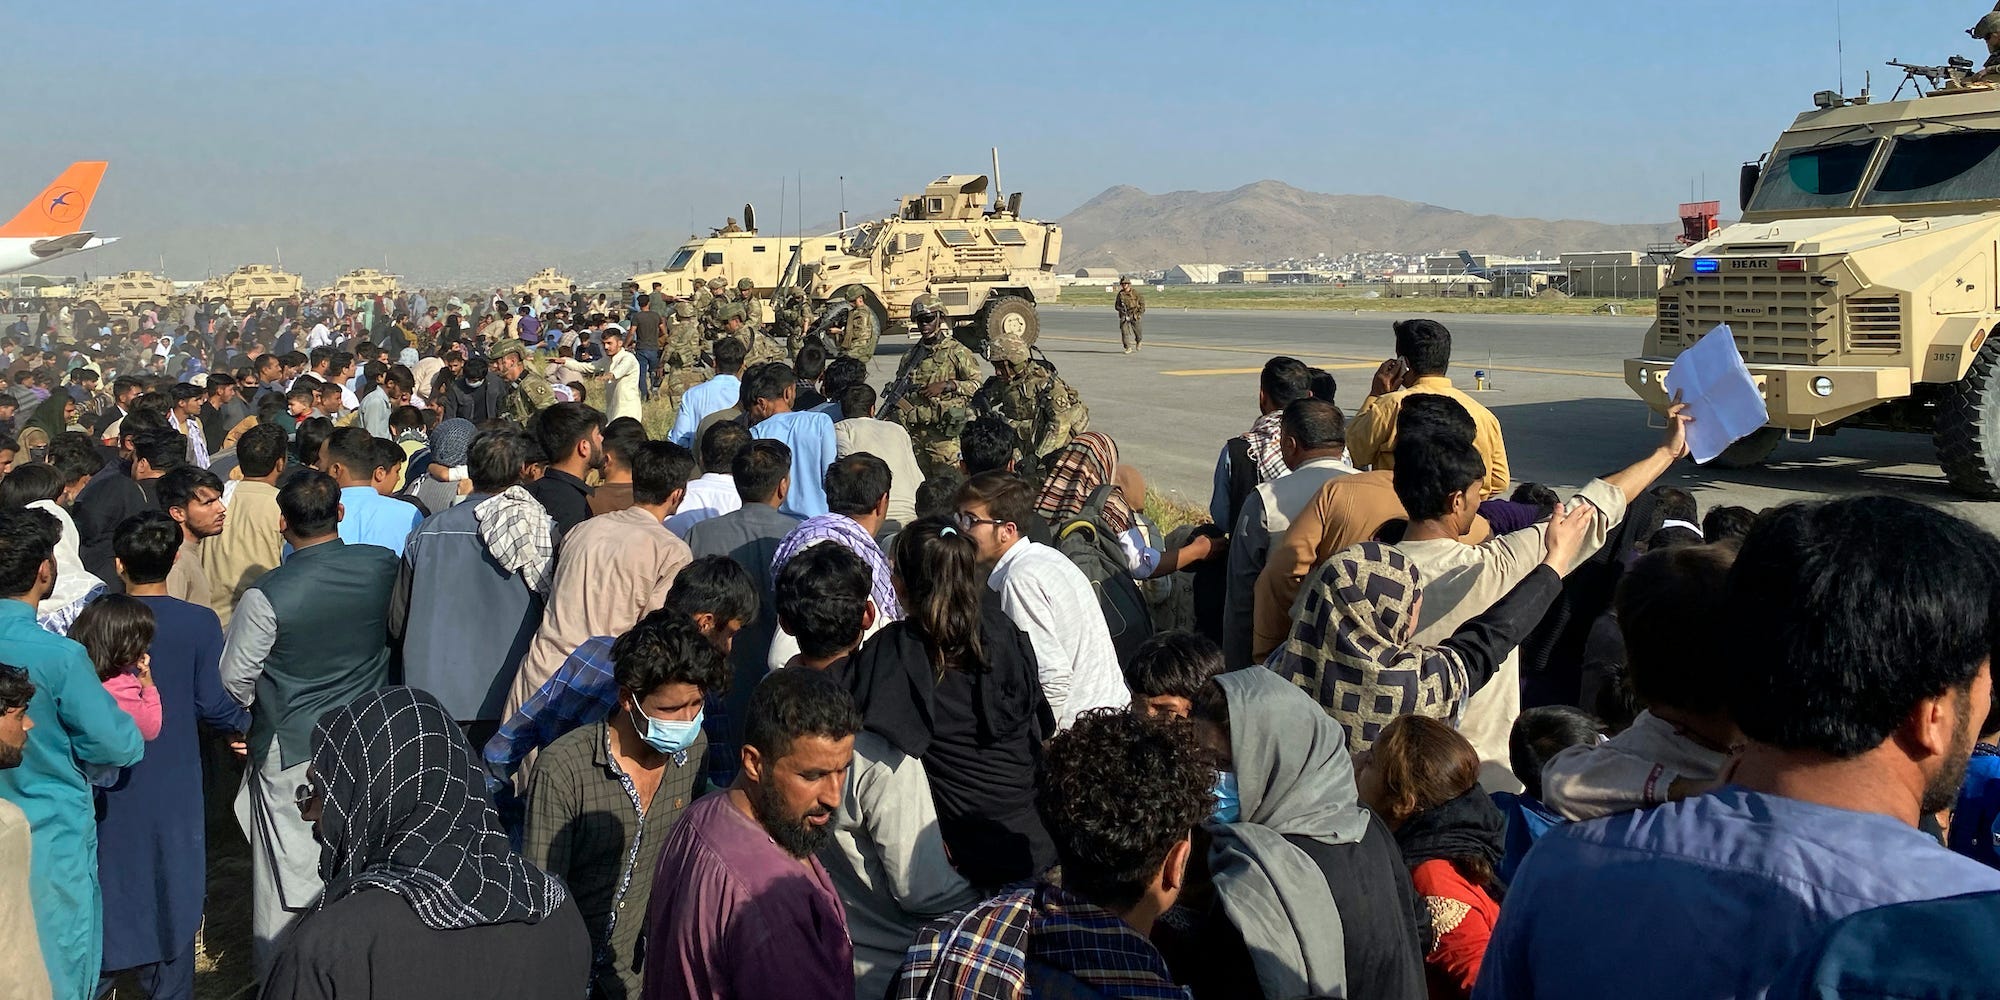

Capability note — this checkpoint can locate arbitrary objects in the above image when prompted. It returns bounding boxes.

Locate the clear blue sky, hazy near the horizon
[11,0,1984,274]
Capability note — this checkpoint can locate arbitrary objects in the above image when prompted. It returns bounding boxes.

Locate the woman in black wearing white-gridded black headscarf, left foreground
[262,688,590,1000]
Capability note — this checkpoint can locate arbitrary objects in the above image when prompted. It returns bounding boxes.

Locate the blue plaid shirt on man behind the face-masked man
[484,636,738,792]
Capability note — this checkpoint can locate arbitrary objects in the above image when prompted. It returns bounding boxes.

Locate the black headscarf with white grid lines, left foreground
[312,688,568,930]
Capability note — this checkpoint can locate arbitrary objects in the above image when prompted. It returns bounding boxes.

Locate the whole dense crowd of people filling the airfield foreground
[0,286,2000,1000]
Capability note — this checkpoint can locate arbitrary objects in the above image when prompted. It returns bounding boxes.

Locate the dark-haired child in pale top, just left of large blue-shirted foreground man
[1542,546,1740,820]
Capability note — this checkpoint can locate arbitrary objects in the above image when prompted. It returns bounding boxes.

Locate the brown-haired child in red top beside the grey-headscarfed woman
[1356,716,1506,998]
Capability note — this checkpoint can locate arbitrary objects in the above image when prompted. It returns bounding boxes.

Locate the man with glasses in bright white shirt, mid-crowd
[956,472,1132,730]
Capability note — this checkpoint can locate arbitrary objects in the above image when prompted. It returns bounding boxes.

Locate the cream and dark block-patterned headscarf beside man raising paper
[1270,542,1472,752]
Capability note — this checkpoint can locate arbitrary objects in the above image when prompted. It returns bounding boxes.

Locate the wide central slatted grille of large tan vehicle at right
[1678,274,1838,364]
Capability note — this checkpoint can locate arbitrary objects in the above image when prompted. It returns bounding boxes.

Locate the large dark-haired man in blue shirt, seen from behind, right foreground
[1480,496,2000,998]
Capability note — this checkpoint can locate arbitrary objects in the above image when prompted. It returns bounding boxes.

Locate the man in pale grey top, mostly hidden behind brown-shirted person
[1222,398,1354,670]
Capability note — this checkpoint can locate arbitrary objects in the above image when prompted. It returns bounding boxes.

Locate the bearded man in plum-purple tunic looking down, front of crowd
[642,666,862,1000]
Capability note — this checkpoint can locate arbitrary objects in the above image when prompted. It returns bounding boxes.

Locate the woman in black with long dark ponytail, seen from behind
[846,518,1056,890]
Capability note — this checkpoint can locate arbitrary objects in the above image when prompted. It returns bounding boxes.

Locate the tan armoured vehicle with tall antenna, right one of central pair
[784,174,1062,350]
